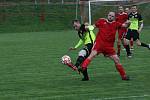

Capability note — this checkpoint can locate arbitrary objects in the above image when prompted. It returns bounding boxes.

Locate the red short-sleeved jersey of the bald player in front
[95,18,122,47]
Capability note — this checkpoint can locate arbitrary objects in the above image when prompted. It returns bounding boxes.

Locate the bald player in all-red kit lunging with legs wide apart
[82,12,129,80]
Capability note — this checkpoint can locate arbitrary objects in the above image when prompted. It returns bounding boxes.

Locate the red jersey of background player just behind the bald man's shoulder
[116,12,128,24]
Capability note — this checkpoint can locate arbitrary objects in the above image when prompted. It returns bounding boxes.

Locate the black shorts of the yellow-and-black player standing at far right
[126,29,139,41]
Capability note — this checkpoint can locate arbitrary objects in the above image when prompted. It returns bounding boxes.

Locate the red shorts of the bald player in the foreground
[92,41,116,56]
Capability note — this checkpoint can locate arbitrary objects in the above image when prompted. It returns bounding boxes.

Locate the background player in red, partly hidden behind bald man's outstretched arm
[116,6,128,56]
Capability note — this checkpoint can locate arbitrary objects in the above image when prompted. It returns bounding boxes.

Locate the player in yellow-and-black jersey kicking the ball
[67,20,95,81]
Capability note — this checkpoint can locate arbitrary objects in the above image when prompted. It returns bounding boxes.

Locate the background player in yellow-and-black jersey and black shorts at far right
[126,5,150,57]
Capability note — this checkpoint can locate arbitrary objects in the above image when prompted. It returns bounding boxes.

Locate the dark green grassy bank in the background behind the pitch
[0,0,150,33]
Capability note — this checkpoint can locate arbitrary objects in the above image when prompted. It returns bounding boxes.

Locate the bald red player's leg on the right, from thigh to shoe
[109,54,129,80]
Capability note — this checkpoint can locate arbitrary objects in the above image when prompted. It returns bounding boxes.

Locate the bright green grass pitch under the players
[0,29,150,100]
